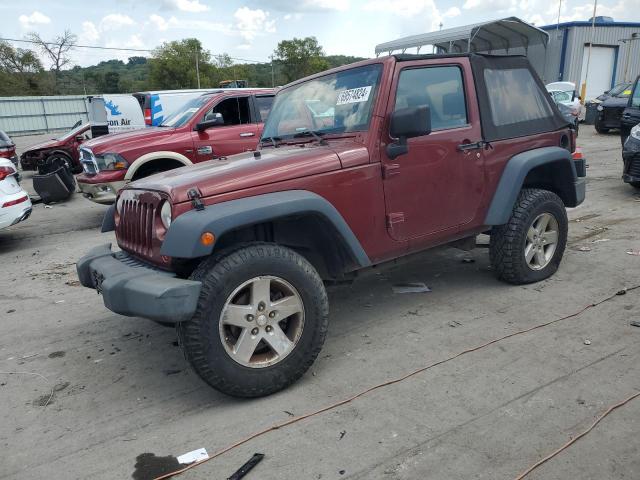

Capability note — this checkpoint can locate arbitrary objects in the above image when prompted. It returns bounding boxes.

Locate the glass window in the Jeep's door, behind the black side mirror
[395,67,468,130]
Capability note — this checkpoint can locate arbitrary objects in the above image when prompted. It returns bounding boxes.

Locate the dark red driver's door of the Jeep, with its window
[382,58,484,243]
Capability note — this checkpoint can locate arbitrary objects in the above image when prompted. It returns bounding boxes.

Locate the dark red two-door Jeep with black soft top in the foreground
[77,54,585,397]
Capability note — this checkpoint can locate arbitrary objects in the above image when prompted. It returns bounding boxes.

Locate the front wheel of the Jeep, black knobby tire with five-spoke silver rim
[177,243,329,397]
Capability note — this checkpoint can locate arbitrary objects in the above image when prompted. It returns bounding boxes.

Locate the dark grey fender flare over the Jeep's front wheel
[160,190,371,267]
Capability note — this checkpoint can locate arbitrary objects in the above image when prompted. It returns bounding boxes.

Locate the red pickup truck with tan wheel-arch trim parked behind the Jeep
[77,89,275,204]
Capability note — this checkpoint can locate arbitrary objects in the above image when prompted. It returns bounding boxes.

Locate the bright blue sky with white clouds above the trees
[0,0,640,65]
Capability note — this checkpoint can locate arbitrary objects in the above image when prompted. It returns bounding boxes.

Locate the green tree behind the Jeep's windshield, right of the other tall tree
[273,37,329,82]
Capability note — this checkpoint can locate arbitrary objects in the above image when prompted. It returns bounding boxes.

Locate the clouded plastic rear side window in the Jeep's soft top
[484,68,553,126]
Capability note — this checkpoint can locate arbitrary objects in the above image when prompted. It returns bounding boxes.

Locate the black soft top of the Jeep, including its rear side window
[394,53,568,142]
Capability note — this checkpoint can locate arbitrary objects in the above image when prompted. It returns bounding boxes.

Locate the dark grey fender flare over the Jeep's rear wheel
[484,147,584,225]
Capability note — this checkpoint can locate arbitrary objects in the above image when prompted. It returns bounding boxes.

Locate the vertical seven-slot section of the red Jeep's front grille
[116,198,158,257]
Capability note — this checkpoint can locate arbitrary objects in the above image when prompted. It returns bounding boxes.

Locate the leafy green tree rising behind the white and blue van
[149,38,211,89]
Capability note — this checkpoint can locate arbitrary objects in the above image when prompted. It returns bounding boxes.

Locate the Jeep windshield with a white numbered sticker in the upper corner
[262,64,382,140]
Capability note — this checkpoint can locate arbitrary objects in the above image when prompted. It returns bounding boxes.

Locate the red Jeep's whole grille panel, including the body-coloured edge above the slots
[116,189,163,260]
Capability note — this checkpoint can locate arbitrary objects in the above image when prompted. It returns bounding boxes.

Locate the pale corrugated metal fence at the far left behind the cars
[0,95,89,136]
